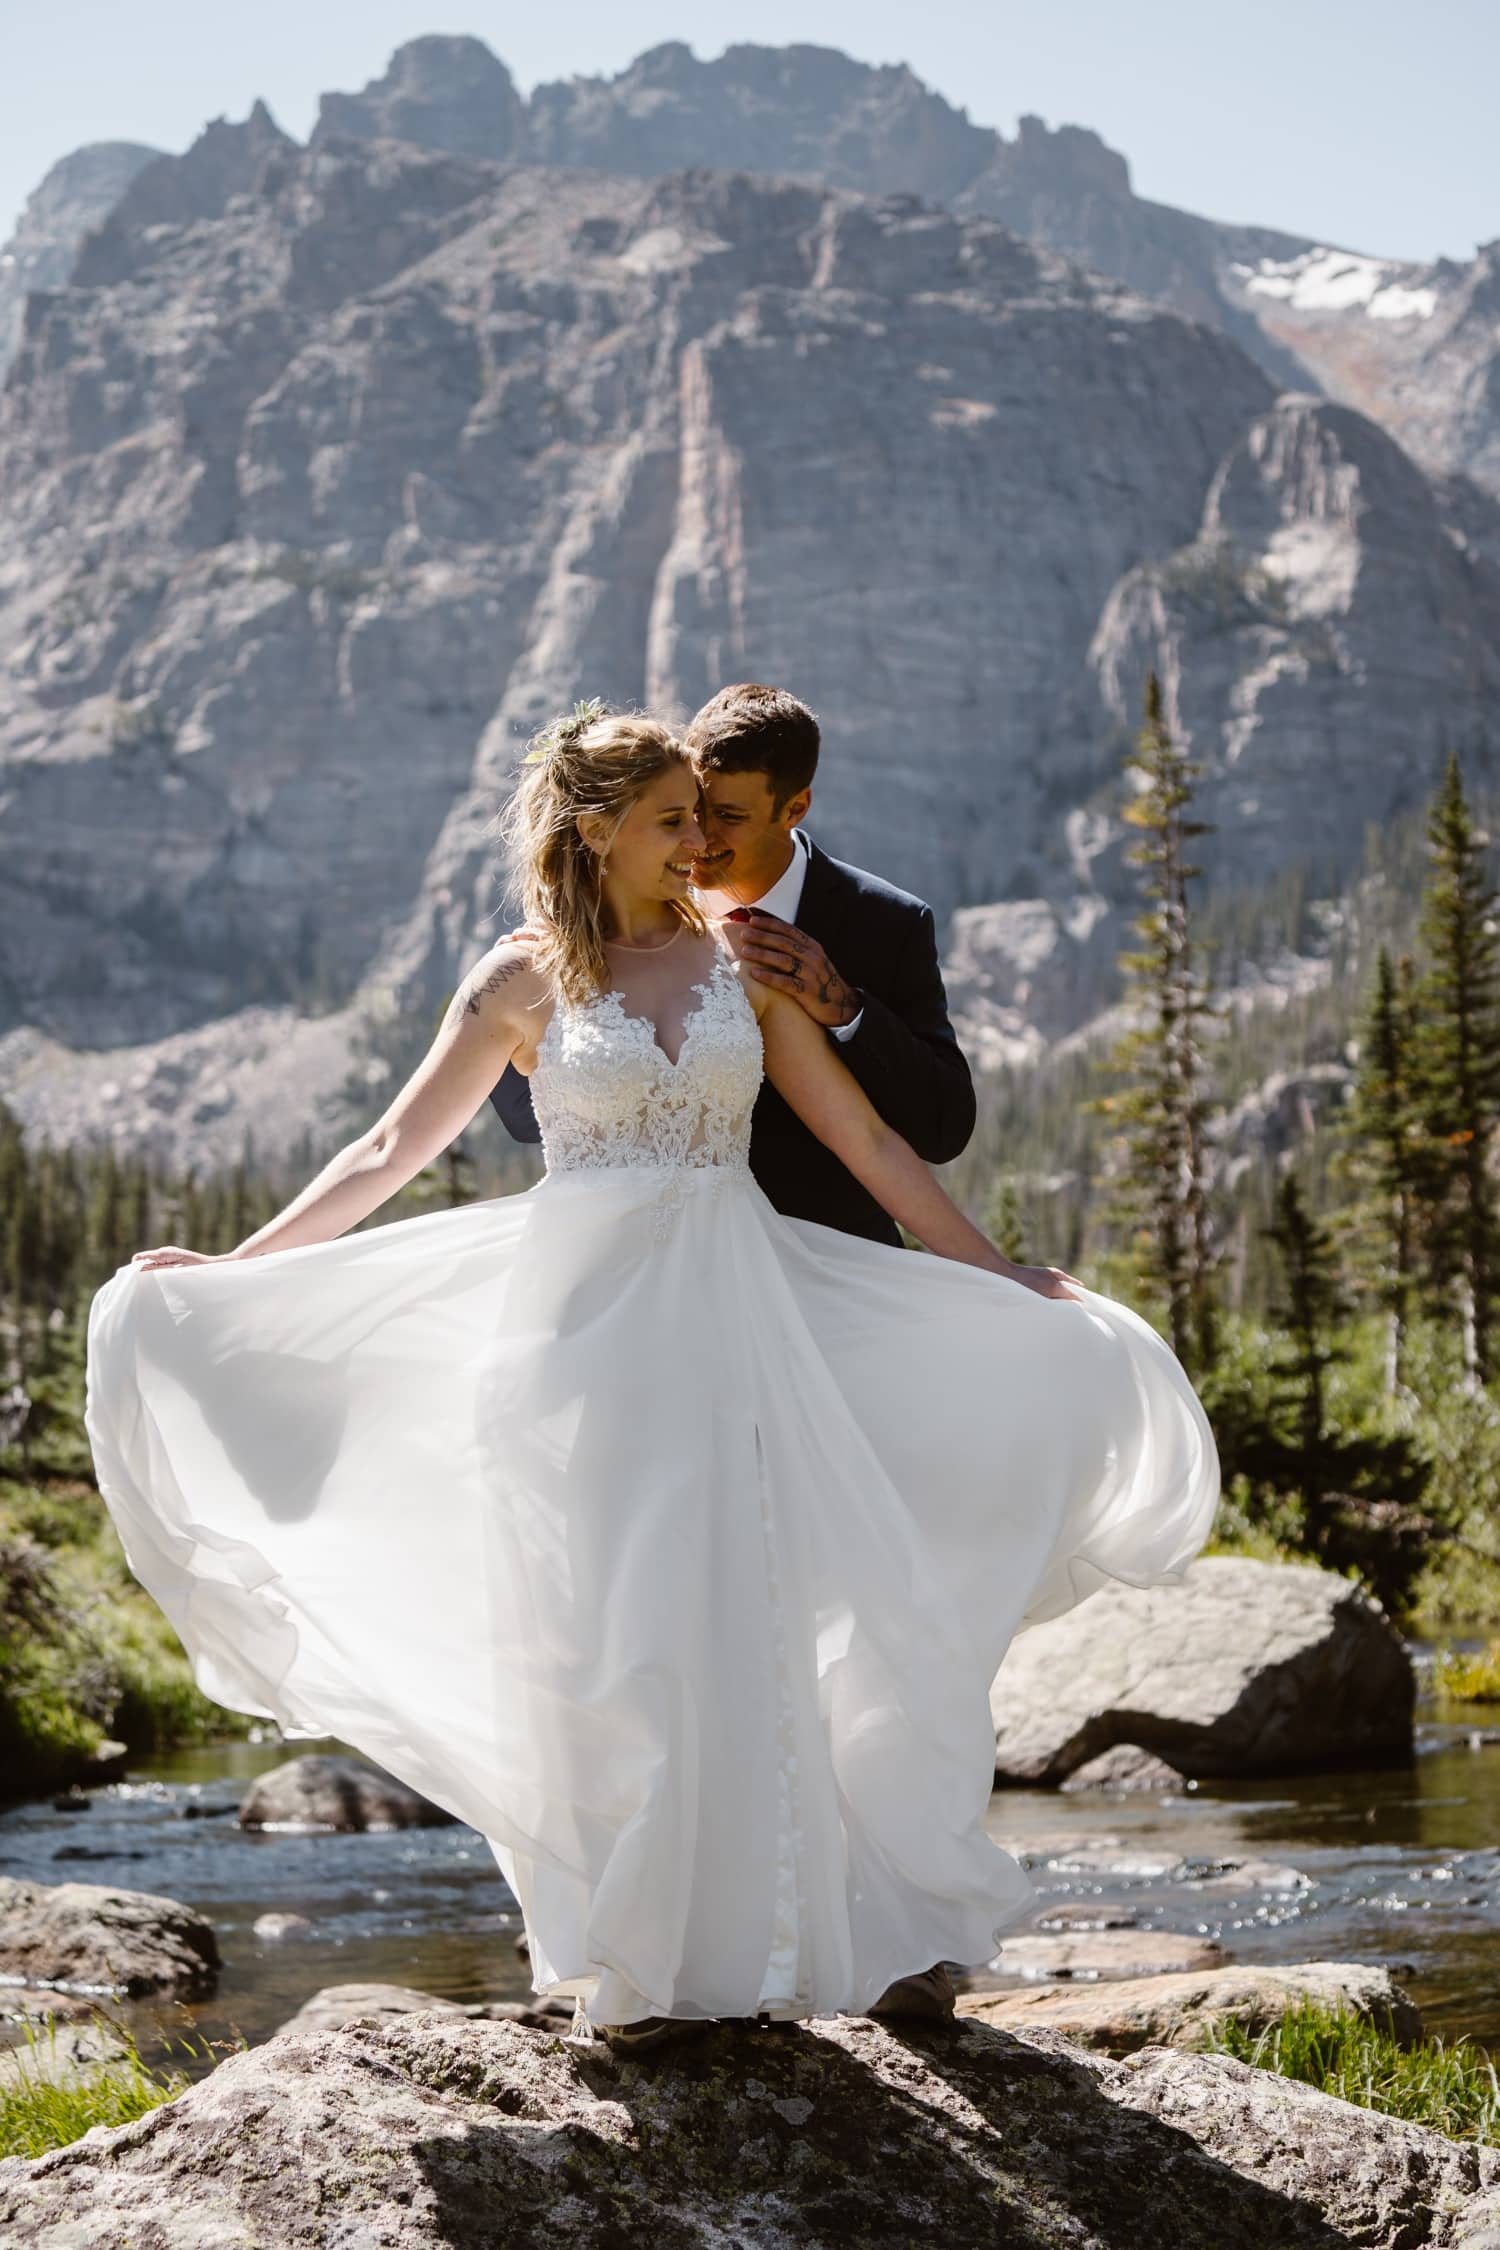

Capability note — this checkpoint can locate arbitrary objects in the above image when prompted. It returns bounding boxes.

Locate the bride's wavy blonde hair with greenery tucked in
[497,700,708,1001]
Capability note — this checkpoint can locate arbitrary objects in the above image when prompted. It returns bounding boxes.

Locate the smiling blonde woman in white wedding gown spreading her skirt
[85,718,1219,2043]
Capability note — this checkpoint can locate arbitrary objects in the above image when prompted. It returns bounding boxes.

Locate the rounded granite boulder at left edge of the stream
[0,1874,220,1998]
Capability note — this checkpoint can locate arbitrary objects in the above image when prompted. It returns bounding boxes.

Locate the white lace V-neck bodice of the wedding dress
[531,950,762,1215]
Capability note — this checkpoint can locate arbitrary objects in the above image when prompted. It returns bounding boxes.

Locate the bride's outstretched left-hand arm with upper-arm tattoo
[133,941,544,1267]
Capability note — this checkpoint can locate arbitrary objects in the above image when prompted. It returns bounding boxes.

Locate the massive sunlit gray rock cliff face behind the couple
[0,52,1500,1161]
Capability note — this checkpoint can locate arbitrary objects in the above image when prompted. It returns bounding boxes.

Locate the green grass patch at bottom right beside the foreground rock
[1205,2000,1500,2147]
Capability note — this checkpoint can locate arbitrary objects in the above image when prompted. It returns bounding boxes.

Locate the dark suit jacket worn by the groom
[490,844,974,1242]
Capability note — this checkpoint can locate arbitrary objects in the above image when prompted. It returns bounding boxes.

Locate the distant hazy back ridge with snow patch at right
[299,38,1500,491]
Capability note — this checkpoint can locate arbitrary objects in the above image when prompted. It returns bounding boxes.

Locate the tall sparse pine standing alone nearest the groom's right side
[1100,673,1214,1370]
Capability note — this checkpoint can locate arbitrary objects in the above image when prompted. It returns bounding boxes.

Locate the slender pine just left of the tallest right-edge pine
[1343,947,1426,1395]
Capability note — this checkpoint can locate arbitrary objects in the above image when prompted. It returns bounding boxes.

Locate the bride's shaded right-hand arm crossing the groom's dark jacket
[742,970,1073,1296]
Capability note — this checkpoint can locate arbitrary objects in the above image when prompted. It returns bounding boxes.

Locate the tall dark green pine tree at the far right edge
[1415,756,1500,1386]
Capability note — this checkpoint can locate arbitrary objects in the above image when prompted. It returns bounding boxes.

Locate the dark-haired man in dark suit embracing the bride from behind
[490,684,974,1242]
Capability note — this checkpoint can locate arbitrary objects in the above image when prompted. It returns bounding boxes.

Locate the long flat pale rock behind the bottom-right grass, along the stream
[958,1962,1421,2054]
